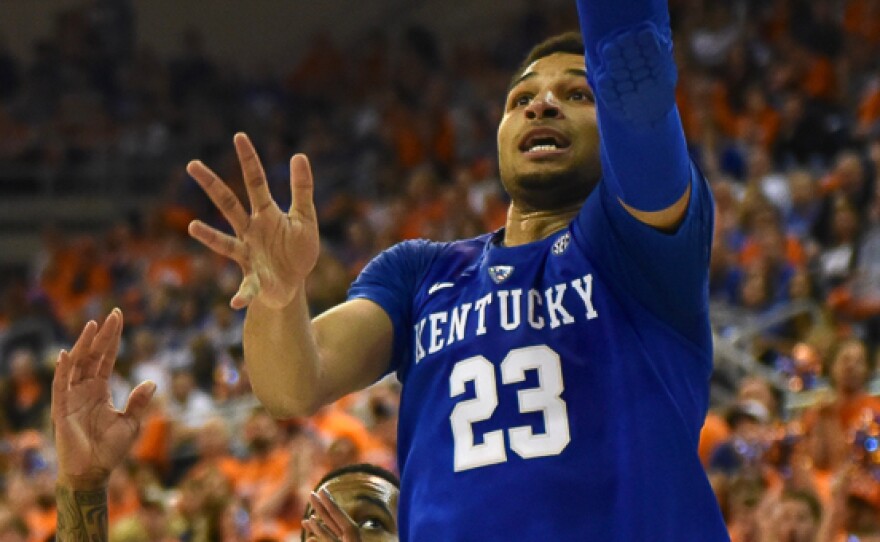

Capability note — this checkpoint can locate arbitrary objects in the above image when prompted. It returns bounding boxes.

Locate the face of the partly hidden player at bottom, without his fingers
[319,472,400,542]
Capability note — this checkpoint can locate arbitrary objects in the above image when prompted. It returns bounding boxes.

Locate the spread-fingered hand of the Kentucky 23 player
[187,134,319,309]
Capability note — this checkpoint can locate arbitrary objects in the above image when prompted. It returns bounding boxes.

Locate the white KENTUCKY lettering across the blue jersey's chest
[415,274,599,363]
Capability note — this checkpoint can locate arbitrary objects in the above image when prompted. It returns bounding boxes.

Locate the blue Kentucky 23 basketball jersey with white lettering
[350,164,728,542]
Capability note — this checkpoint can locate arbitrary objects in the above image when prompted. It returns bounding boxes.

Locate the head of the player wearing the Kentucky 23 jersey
[498,32,601,215]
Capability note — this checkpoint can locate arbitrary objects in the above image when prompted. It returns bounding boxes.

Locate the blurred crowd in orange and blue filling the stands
[0,0,880,542]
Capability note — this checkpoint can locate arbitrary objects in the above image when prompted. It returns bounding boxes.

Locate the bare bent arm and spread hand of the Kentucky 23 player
[187,134,393,418]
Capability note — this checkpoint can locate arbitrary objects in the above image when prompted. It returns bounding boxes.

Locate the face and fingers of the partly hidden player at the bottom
[302,472,400,542]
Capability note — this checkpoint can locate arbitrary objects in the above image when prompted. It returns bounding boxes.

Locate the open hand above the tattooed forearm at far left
[52,309,156,488]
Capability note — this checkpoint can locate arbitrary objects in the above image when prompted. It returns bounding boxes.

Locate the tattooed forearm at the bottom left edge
[55,484,108,542]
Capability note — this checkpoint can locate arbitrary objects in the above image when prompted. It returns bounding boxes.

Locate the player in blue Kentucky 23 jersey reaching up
[188,0,728,542]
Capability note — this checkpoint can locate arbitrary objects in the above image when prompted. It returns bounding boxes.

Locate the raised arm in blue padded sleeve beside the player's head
[577,0,691,229]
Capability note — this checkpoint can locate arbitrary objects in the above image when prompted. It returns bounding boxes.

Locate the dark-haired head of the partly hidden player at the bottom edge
[300,463,400,542]
